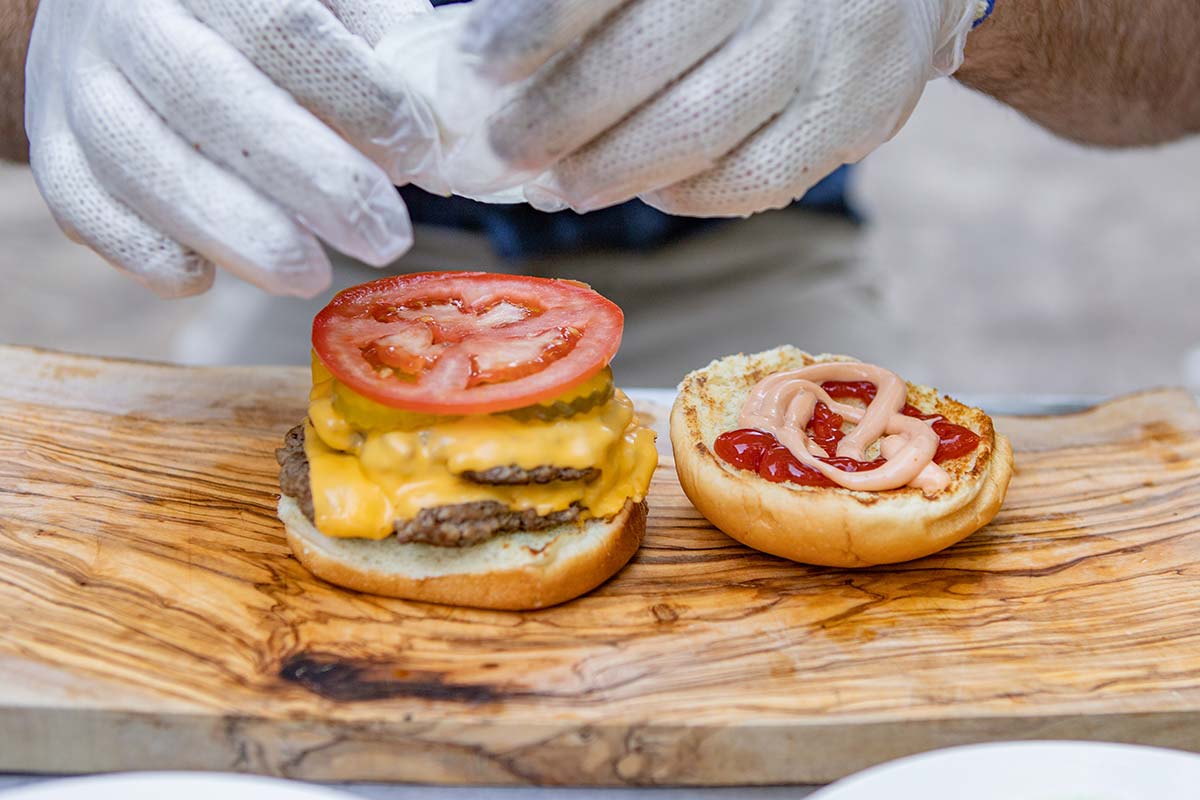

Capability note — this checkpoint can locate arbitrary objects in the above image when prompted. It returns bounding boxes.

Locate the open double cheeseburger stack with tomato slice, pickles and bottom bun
[276,272,658,609]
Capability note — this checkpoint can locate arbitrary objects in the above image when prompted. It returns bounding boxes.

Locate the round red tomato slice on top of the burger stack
[312,272,624,414]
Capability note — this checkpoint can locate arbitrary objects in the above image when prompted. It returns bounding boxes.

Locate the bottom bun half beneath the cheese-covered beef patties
[278,495,646,609]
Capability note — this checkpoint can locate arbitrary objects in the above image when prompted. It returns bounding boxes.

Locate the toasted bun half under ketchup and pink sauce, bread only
[671,347,1013,567]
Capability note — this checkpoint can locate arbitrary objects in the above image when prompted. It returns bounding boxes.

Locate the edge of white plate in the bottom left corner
[0,772,353,800]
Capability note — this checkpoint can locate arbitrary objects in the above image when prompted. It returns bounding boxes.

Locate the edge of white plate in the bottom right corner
[809,741,1200,800]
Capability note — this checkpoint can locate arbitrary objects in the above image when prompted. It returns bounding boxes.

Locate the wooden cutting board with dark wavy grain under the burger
[0,348,1200,784]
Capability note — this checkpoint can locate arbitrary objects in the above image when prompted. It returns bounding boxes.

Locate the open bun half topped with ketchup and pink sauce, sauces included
[671,347,1013,567]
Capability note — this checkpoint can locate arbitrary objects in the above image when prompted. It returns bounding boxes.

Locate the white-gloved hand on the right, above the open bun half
[460,0,979,216]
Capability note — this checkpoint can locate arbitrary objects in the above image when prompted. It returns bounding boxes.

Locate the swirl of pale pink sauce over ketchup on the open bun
[738,361,950,495]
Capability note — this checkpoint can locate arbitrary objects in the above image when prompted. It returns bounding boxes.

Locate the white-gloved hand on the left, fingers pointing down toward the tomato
[25,0,437,296]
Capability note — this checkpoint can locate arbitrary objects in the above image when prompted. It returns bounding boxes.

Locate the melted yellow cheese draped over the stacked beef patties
[305,359,658,539]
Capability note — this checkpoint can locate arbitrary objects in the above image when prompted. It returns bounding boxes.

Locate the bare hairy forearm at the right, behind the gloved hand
[956,0,1200,146]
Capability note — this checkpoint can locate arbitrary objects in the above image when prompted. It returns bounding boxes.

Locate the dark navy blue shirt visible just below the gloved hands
[400,0,858,260]
